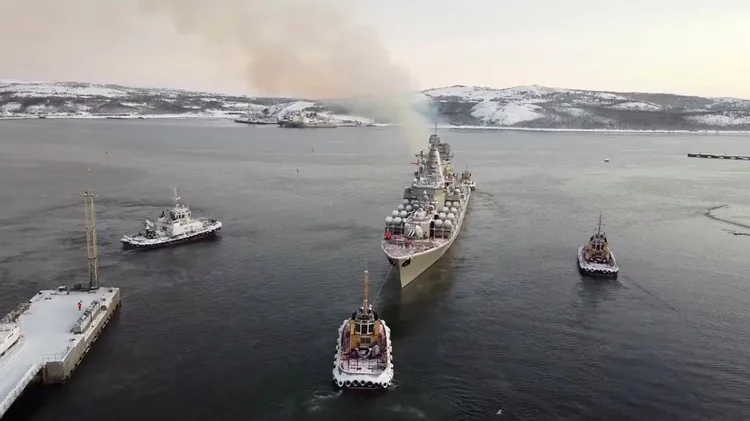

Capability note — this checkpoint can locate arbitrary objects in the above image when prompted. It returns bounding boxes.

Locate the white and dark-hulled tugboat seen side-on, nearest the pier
[120,189,222,249]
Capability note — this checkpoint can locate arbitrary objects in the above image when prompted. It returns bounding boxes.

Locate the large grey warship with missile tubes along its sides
[381,132,472,288]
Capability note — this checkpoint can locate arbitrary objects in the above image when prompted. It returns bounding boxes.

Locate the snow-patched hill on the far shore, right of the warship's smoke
[422,86,750,130]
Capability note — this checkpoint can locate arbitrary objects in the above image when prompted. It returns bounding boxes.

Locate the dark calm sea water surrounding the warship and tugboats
[0,120,750,421]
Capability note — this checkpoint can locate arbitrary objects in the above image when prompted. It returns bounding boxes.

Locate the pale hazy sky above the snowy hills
[0,0,750,98]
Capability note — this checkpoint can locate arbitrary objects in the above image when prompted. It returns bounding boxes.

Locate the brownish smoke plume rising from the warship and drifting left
[0,0,427,149]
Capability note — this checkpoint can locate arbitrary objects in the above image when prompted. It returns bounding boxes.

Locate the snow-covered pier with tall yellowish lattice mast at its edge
[0,191,120,418]
